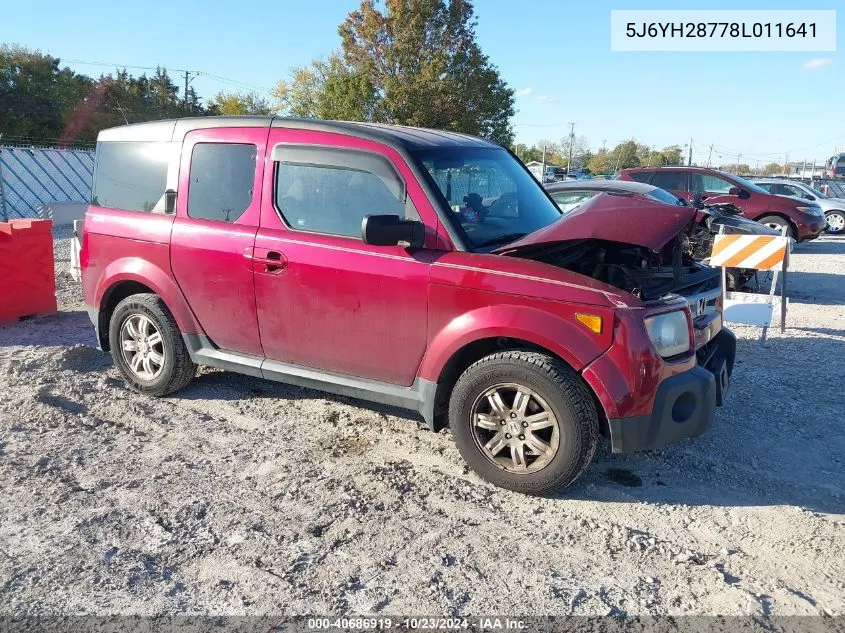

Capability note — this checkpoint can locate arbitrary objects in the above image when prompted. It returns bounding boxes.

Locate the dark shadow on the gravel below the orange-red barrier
[0,310,97,347]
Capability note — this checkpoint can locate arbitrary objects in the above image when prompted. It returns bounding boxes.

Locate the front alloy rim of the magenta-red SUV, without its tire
[471,383,560,474]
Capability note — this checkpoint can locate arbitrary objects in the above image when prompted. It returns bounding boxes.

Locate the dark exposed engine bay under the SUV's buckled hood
[510,233,720,301]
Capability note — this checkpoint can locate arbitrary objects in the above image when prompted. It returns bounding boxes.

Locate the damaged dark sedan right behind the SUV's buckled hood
[546,180,780,290]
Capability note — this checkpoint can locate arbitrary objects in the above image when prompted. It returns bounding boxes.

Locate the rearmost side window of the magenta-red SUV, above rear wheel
[91,142,172,213]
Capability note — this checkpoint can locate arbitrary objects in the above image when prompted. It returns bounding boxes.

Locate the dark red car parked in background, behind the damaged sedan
[619,167,827,242]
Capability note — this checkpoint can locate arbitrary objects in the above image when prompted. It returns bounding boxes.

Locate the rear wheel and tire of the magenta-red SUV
[109,293,197,396]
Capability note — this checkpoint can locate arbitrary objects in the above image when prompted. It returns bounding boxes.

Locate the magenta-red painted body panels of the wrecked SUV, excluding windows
[83,117,728,440]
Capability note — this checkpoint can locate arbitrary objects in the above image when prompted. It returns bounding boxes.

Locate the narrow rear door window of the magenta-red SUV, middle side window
[188,143,258,222]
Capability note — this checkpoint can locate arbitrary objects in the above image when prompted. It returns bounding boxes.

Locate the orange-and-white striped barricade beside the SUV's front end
[710,227,792,344]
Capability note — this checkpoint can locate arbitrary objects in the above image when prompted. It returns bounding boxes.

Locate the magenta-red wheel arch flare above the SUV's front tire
[418,305,613,382]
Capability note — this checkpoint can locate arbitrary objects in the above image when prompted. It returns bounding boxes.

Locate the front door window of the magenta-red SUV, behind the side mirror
[273,145,406,239]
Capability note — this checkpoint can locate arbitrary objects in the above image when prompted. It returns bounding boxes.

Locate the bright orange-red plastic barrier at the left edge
[0,220,56,323]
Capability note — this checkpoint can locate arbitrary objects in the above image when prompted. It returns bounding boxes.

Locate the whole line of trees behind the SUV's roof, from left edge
[0,0,515,145]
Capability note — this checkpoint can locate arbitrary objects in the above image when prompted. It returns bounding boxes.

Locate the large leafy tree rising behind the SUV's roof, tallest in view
[276,0,514,145]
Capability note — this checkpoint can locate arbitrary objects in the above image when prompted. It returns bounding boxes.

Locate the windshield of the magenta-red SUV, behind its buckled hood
[415,148,561,250]
